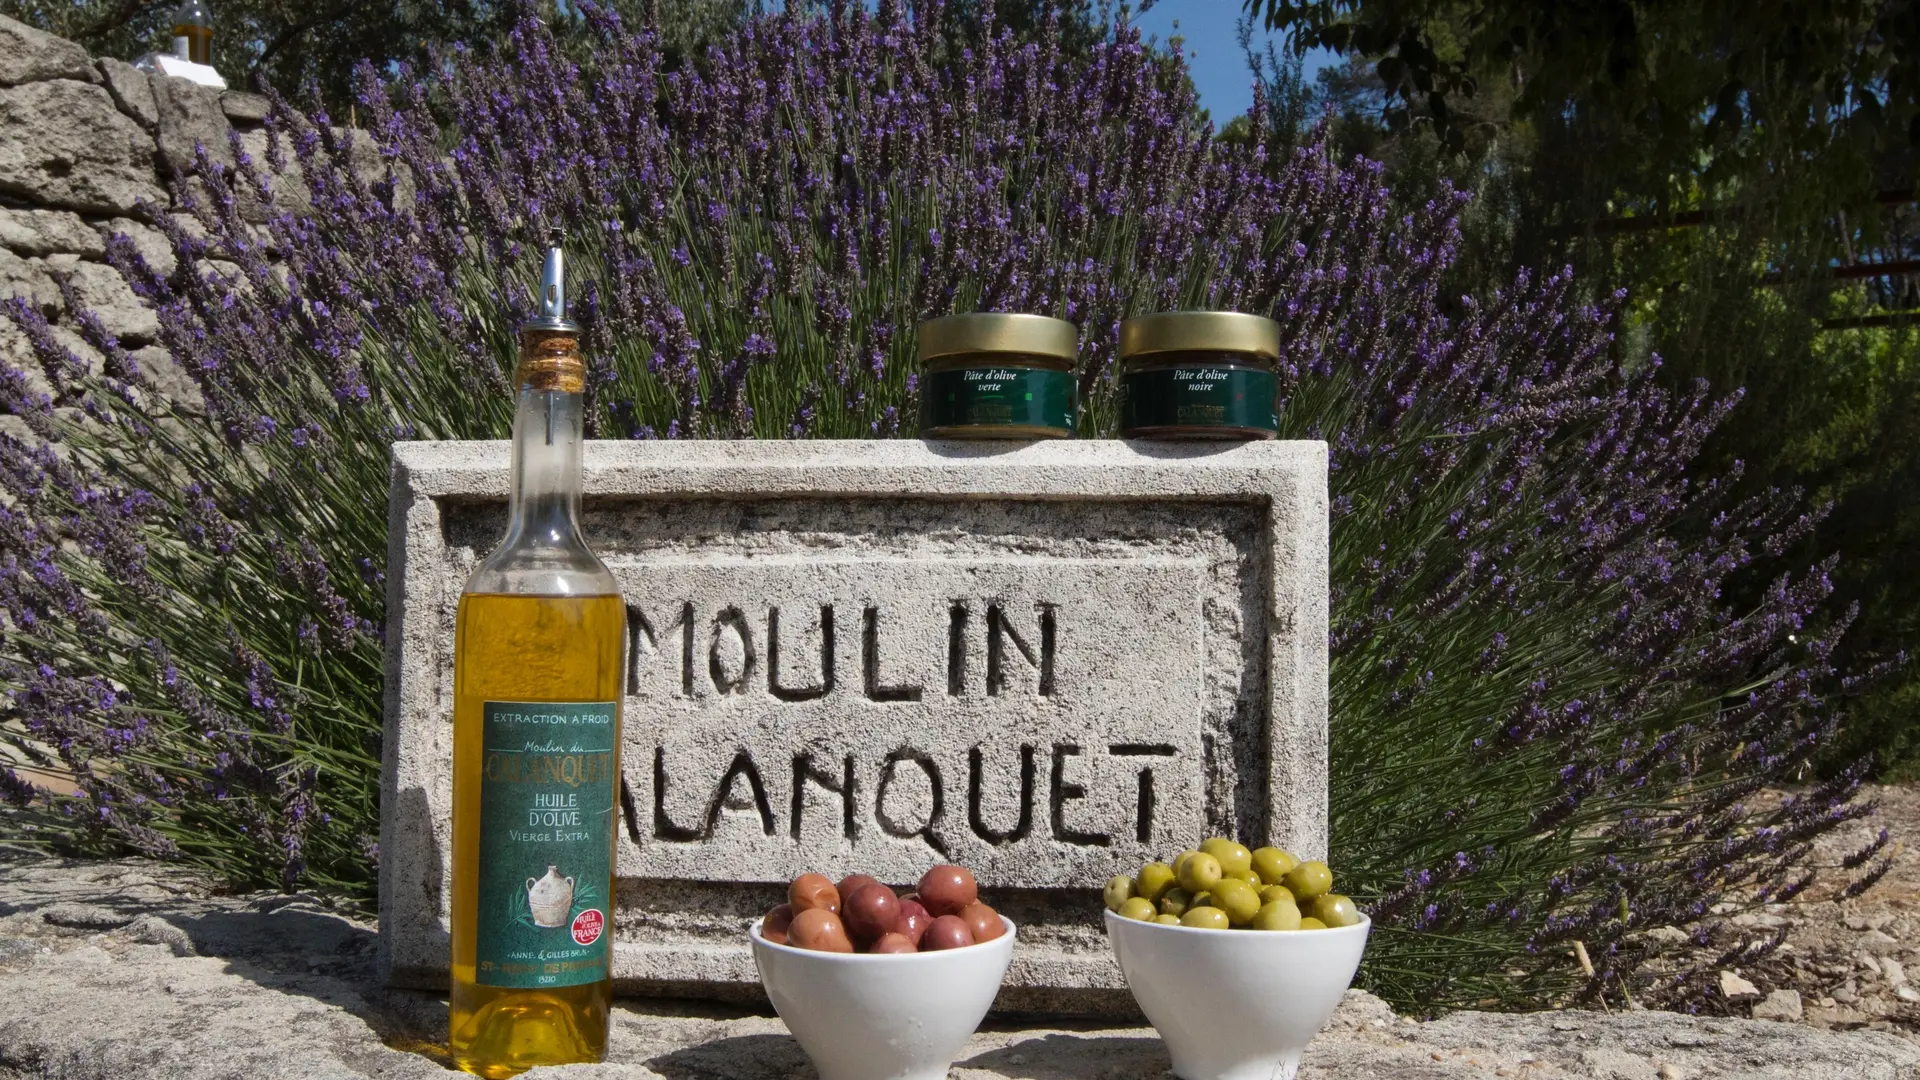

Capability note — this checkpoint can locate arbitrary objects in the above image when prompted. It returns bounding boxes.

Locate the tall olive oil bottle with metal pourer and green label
[447,238,626,1076]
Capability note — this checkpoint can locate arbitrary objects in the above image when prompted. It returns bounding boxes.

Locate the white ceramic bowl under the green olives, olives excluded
[1106,911,1373,1080]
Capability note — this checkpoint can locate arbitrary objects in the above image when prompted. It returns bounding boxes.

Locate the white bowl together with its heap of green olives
[1104,838,1373,1080]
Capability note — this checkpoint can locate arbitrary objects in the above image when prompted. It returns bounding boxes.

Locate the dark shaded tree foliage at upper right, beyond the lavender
[1248,0,1920,763]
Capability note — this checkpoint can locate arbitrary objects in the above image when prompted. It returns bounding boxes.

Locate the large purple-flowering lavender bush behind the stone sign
[0,4,1884,1007]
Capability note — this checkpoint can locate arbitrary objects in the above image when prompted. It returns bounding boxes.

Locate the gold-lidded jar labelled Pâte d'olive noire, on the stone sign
[1119,311,1281,438]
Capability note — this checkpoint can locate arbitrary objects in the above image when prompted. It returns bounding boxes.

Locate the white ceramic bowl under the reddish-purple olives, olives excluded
[749,915,1014,1080]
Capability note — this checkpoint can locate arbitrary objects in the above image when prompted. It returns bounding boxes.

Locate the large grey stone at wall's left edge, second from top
[0,79,165,213]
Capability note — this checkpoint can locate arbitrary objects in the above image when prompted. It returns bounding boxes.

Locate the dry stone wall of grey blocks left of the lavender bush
[0,15,288,424]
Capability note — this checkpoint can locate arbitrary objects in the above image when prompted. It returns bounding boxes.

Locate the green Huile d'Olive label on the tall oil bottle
[474,701,618,988]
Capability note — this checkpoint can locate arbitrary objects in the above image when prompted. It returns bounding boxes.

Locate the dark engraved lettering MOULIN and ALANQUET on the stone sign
[626,601,1179,855]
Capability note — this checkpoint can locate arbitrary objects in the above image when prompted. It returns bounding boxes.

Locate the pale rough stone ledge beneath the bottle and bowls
[0,853,1920,1080]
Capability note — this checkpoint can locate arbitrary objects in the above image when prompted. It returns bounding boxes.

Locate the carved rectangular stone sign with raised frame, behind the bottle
[380,440,1327,1011]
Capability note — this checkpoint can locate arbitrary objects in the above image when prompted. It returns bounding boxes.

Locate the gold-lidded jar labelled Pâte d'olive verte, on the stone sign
[920,313,1079,438]
